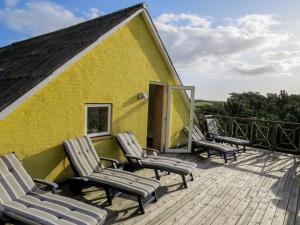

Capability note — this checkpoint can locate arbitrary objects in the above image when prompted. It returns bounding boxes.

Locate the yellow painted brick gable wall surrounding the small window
[0,16,190,180]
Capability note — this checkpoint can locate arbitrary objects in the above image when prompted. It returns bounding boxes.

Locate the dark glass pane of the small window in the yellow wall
[87,107,109,134]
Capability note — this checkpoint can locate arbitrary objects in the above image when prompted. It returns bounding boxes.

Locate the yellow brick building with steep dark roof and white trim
[0,4,193,180]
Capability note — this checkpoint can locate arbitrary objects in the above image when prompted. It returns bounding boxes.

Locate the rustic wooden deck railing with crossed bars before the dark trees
[199,116,300,154]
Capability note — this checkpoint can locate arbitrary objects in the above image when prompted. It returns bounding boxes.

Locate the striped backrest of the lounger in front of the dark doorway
[116,132,144,158]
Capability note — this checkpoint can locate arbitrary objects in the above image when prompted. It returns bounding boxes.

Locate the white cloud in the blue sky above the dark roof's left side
[0,0,102,35]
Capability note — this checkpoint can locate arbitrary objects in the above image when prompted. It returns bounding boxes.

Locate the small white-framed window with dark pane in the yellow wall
[86,104,111,137]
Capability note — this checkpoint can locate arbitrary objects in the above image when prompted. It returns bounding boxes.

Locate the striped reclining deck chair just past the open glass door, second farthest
[183,125,238,163]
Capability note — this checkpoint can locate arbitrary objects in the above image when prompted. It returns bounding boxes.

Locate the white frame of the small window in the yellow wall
[84,103,112,137]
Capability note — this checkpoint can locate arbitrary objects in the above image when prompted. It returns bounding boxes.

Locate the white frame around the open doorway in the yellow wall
[148,81,168,152]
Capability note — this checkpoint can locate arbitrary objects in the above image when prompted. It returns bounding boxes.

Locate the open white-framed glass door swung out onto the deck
[165,85,195,153]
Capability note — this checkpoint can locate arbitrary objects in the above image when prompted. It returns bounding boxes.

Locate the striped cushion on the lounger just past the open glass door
[184,125,236,152]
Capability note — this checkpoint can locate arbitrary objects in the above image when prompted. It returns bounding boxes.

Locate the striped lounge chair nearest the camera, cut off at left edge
[0,153,107,225]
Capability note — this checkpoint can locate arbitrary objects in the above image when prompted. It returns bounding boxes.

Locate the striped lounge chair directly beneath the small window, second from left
[64,136,160,214]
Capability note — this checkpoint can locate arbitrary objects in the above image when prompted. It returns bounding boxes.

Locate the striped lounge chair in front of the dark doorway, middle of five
[116,132,197,188]
